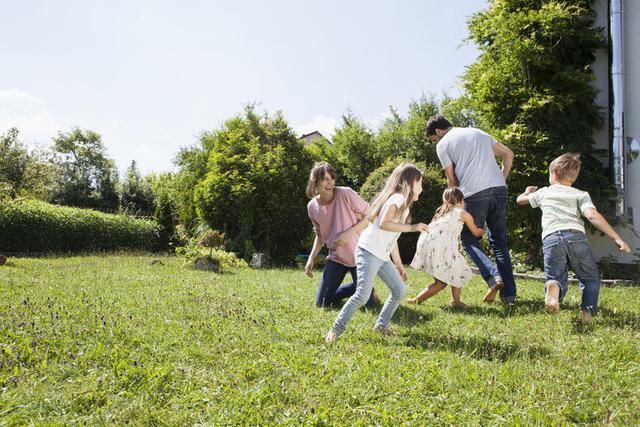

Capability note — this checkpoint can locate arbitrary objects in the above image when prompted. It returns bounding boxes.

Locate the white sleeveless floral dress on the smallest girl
[411,208,473,288]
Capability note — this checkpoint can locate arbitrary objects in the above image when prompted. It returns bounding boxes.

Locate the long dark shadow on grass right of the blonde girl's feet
[406,333,551,362]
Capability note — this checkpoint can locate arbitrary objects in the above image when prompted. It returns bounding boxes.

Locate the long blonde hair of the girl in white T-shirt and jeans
[369,162,422,222]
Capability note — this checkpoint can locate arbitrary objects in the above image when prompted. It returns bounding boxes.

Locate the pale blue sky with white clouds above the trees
[0,0,488,174]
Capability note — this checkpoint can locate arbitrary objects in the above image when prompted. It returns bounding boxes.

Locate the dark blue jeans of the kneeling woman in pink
[316,260,375,307]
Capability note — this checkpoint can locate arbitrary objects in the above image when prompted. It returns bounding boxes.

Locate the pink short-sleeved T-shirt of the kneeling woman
[307,187,369,267]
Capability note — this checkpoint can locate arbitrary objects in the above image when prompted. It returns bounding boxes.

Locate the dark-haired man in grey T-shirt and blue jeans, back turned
[426,114,516,304]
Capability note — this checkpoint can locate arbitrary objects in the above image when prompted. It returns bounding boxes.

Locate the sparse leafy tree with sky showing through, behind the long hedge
[53,128,118,209]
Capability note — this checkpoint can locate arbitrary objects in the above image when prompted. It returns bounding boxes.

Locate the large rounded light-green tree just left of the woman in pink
[194,106,312,264]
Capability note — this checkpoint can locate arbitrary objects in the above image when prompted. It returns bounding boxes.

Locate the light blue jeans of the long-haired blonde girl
[331,248,407,335]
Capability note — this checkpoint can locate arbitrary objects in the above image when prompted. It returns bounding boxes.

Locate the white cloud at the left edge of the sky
[0,88,60,143]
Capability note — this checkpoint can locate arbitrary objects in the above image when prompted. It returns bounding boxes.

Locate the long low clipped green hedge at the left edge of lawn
[0,200,163,252]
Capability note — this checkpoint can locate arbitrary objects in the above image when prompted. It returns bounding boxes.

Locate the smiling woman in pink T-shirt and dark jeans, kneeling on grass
[304,162,376,307]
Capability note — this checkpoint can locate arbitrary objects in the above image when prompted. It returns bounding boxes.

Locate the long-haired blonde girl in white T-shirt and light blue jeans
[325,163,427,343]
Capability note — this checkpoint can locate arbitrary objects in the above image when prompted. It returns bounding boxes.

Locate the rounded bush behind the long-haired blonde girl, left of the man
[360,159,447,263]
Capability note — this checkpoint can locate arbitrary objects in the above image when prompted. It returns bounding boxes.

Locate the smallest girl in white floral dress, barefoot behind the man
[408,187,482,307]
